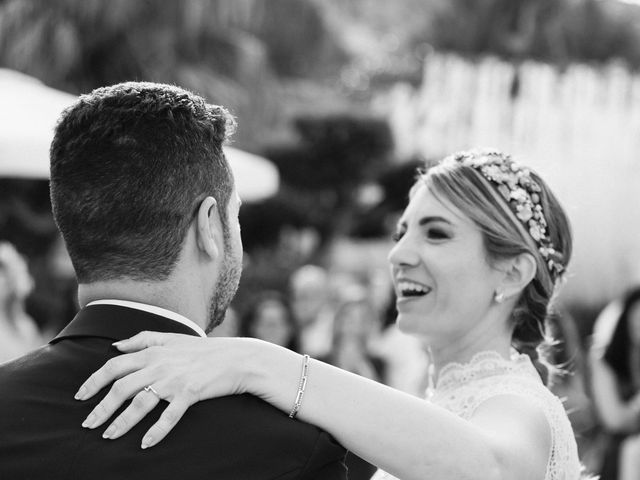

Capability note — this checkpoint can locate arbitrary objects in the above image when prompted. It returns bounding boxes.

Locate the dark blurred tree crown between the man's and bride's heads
[266,114,393,248]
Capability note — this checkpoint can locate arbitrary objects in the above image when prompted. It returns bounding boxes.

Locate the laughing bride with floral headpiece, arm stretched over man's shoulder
[76,151,581,480]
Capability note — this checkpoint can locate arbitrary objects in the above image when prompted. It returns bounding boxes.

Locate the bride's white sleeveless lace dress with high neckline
[372,352,581,480]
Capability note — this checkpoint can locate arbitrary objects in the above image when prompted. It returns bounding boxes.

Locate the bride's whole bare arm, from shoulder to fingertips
[77,333,550,480]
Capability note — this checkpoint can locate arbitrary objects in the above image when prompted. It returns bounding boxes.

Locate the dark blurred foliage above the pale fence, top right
[424,0,640,67]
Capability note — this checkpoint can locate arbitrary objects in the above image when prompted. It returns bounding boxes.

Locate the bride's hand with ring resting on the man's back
[75,332,256,448]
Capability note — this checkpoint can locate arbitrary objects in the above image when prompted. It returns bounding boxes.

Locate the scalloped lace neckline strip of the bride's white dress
[427,350,539,397]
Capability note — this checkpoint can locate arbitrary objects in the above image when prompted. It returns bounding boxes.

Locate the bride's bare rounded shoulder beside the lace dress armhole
[470,394,552,479]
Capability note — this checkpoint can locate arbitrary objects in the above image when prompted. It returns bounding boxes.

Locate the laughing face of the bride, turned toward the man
[389,185,508,344]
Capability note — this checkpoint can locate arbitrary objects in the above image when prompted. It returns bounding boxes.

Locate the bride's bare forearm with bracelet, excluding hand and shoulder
[247,347,499,480]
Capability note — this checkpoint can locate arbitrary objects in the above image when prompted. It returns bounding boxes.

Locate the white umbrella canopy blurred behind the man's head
[0,69,279,201]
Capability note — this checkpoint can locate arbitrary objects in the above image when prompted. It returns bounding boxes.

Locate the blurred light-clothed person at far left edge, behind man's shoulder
[0,242,43,363]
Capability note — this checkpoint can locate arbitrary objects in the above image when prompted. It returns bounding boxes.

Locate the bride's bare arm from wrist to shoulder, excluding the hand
[252,348,550,480]
